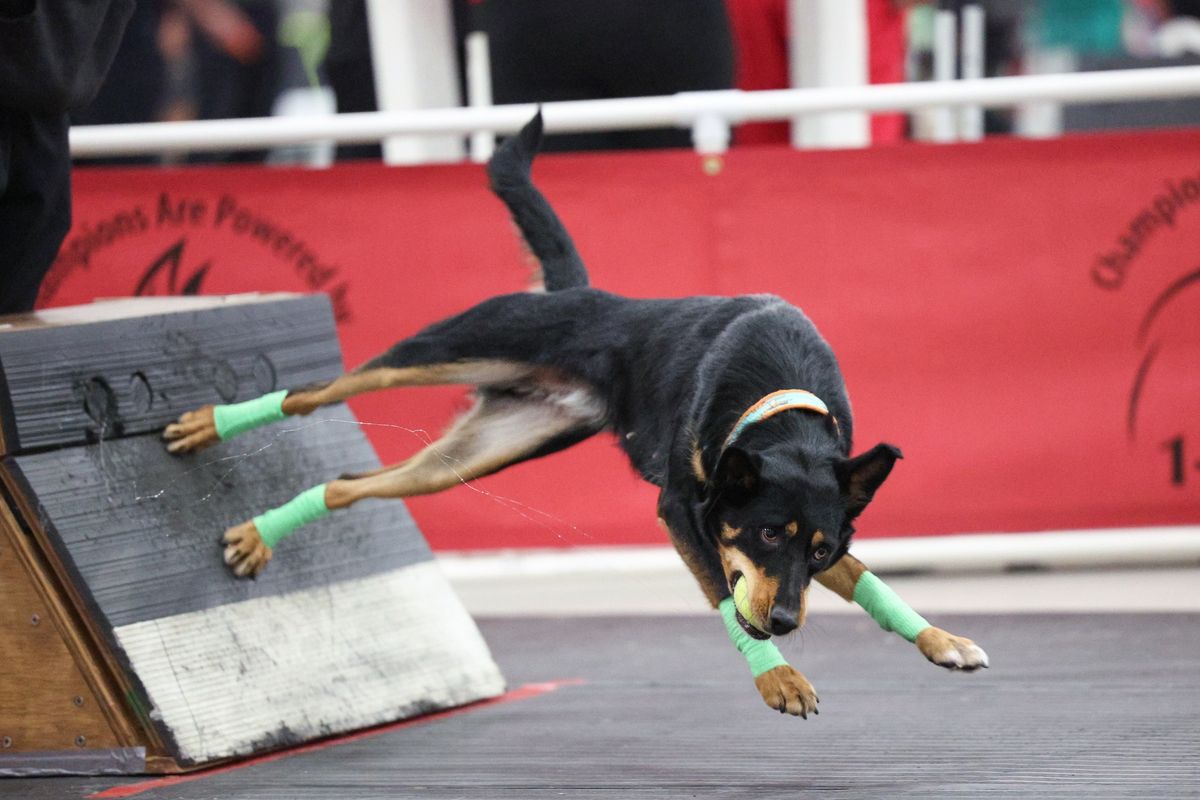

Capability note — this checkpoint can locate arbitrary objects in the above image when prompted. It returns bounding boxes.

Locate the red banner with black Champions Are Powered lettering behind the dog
[42,132,1200,548]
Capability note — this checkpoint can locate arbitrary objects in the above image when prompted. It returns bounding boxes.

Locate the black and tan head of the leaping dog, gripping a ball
[704,440,901,638]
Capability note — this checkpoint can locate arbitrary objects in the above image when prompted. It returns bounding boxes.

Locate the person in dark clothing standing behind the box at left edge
[0,0,133,314]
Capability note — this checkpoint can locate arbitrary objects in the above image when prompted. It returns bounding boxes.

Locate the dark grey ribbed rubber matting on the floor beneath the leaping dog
[0,618,1200,800]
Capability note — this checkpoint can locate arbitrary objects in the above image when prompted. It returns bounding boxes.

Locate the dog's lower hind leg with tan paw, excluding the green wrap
[224,395,602,577]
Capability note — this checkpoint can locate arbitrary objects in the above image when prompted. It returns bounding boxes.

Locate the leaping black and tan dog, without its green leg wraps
[164,115,986,715]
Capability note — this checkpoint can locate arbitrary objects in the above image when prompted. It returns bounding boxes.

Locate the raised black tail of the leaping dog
[487,108,588,291]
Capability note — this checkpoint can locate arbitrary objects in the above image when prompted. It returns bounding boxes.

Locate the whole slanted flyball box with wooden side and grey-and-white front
[0,295,504,775]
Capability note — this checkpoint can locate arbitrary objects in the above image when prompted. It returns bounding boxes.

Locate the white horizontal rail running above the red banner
[71,66,1200,156]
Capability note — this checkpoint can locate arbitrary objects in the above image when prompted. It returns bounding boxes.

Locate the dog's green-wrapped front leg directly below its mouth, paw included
[659,501,820,720]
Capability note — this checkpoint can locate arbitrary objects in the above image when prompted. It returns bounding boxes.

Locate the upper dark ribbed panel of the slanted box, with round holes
[0,295,342,452]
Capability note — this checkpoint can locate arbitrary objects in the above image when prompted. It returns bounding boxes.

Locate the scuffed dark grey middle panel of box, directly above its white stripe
[8,417,433,627]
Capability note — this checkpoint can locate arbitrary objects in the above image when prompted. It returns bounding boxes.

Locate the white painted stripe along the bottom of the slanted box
[115,561,504,763]
